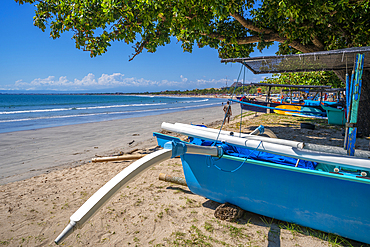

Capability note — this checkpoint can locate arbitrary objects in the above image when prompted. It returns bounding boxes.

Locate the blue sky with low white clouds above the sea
[0,0,277,92]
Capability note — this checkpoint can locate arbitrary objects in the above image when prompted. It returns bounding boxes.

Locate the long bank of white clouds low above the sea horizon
[4,73,231,92]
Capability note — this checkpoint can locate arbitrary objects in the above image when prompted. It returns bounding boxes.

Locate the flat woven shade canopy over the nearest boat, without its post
[221,46,370,74]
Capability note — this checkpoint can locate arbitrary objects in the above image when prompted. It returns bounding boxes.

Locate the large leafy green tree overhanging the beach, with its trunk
[15,0,370,135]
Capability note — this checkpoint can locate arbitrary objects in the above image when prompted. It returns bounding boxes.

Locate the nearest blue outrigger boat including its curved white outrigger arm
[55,46,370,244]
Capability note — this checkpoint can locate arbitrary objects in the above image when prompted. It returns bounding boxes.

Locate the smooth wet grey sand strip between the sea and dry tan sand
[0,104,223,184]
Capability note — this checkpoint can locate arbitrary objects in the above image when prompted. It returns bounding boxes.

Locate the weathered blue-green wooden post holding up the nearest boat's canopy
[346,54,365,156]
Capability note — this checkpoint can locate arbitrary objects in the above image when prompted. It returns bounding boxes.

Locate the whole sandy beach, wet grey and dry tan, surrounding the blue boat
[0,106,369,246]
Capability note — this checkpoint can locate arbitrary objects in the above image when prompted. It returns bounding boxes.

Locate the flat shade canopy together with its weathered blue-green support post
[221,46,370,156]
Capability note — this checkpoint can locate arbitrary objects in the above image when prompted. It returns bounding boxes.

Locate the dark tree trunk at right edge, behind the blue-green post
[335,70,370,136]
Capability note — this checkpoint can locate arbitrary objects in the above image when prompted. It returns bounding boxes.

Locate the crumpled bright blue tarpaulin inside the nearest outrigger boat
[190,138,317,170]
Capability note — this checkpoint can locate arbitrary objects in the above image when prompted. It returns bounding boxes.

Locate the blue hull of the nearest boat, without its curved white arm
[155,123,370,243]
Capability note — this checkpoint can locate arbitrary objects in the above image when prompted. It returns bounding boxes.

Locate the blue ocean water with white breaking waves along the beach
[0,94,225,133]
